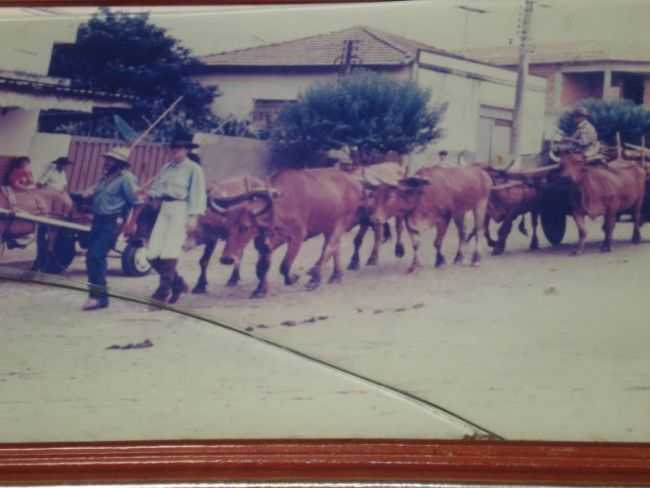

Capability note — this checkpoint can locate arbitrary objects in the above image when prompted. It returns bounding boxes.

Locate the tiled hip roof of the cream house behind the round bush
[200,26,451,67]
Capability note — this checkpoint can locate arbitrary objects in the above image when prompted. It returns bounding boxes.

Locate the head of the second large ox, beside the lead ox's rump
[366,176,429,224]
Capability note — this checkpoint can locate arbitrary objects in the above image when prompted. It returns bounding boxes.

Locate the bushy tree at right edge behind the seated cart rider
[558,98,650,146]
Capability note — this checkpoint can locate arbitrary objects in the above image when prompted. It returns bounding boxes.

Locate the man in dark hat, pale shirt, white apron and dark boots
[148,136,206,303]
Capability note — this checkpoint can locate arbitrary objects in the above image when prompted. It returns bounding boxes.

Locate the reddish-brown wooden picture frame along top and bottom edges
[0,0,650,486]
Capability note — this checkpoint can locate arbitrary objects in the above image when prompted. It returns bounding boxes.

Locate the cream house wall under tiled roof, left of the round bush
[195,68,409,119]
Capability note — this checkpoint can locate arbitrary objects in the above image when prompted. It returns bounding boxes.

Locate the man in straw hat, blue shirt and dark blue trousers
[82,147,138,310]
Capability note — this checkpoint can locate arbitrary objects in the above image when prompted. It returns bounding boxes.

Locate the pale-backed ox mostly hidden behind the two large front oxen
[345,162,406,270]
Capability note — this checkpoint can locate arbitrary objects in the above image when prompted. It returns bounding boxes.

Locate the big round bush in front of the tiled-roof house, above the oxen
[271,71,446,166]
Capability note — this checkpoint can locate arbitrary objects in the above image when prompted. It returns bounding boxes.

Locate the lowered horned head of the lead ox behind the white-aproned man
[208,189,280,264]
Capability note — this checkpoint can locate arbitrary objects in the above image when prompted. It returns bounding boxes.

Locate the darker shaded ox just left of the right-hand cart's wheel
[468,168,542,255]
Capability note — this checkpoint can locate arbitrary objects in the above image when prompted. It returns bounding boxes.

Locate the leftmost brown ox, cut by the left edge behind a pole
[0,189,73,271]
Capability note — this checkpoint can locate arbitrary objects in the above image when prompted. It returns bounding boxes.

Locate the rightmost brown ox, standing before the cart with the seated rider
[560,153,646,255]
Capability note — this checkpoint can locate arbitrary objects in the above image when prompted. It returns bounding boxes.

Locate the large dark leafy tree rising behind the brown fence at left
[50,7,217,139]
